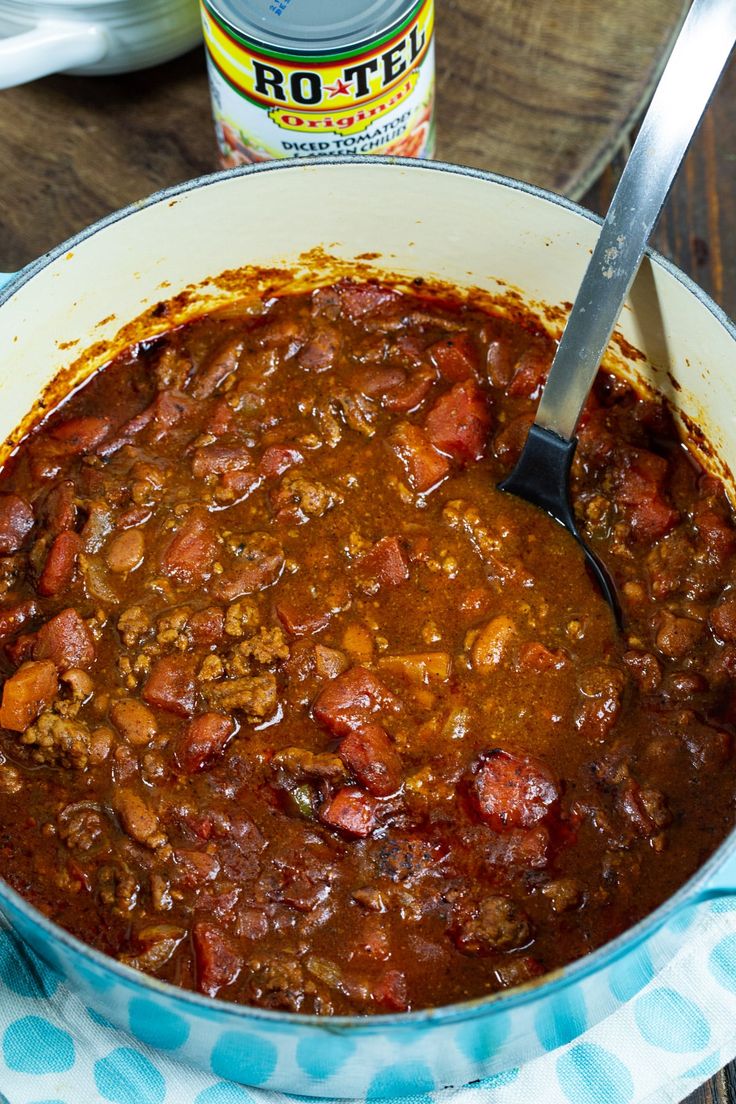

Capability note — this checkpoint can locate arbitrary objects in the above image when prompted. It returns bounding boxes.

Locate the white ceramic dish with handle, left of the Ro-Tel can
[0,0,202,88]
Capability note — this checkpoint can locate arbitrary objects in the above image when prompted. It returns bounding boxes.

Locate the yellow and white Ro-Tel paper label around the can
[201,0,435,168]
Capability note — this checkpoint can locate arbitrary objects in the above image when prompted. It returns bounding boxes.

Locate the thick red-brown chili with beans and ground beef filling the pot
[0,271,736,1015]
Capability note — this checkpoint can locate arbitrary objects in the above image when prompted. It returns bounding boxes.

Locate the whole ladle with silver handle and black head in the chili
[500,0,736,625]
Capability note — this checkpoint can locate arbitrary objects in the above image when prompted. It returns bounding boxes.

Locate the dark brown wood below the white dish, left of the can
[0,50,215,269]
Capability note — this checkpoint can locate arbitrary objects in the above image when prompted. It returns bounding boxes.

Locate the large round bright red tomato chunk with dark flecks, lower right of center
[470,749,559,831]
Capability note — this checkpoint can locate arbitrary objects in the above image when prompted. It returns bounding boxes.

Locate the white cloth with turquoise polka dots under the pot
[0,901,736,1104]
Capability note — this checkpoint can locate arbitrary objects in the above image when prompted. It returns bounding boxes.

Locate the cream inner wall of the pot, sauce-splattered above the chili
[0,158,736,490]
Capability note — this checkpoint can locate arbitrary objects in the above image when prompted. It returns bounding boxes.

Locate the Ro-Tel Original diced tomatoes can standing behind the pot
[201,0,435,168]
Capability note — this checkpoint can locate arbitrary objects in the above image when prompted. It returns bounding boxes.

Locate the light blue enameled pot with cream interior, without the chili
[0,158,736,1096]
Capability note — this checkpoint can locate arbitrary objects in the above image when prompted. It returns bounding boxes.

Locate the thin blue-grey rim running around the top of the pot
[0,155,736,1033]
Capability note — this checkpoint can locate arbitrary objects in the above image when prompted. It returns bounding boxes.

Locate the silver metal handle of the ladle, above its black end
[536,0,736,439]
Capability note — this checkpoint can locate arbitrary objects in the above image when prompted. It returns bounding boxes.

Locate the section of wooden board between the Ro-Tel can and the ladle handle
[437,0,689,197]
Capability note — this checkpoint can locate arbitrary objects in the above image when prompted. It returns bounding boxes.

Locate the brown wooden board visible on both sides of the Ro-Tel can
[0,0,686,268]
